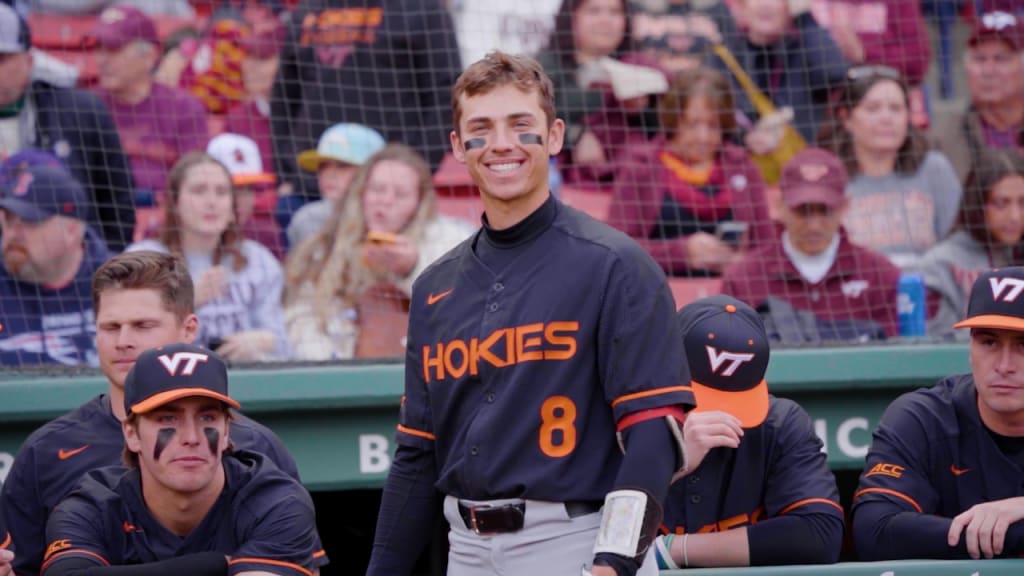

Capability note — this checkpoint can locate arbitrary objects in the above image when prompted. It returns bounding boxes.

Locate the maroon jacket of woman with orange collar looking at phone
[607,136,775,276]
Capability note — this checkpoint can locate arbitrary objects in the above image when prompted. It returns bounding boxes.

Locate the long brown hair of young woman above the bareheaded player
[160,151,248,272]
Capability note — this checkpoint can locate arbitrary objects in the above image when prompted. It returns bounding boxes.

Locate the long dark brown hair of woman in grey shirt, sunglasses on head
[818,71,929,177]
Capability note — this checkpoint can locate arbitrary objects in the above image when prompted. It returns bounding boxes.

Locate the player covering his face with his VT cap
[656,295,844,569]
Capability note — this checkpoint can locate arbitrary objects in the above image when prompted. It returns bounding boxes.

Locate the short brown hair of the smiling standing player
[452,50,555,134]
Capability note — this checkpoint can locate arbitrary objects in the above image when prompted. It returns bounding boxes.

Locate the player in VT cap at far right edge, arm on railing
[853,268,1024,561]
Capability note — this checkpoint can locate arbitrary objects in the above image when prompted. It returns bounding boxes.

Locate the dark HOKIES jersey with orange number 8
[397,199,693,501]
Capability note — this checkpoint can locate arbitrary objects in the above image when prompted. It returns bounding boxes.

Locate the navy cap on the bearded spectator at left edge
[0,160,89,222]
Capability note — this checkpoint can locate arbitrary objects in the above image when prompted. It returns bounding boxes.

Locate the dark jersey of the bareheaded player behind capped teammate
[0,395,299,576]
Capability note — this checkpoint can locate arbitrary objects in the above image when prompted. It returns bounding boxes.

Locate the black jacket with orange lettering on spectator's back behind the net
[270,0,462,194]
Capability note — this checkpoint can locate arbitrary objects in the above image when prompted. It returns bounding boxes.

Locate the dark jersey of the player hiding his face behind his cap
[662,397,843,534]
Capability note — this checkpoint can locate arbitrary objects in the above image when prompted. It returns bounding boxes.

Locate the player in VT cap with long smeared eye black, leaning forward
[42,343,323,576]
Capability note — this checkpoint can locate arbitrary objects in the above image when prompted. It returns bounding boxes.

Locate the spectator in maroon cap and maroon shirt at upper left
[95,6,208,204]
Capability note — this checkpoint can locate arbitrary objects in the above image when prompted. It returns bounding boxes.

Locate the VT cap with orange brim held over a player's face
[679,294,769,428]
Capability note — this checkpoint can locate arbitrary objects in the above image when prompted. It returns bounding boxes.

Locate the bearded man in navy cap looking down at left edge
[0,165,110,366]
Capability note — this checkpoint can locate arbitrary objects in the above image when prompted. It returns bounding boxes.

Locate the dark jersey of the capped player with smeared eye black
[42,452,324,576]
